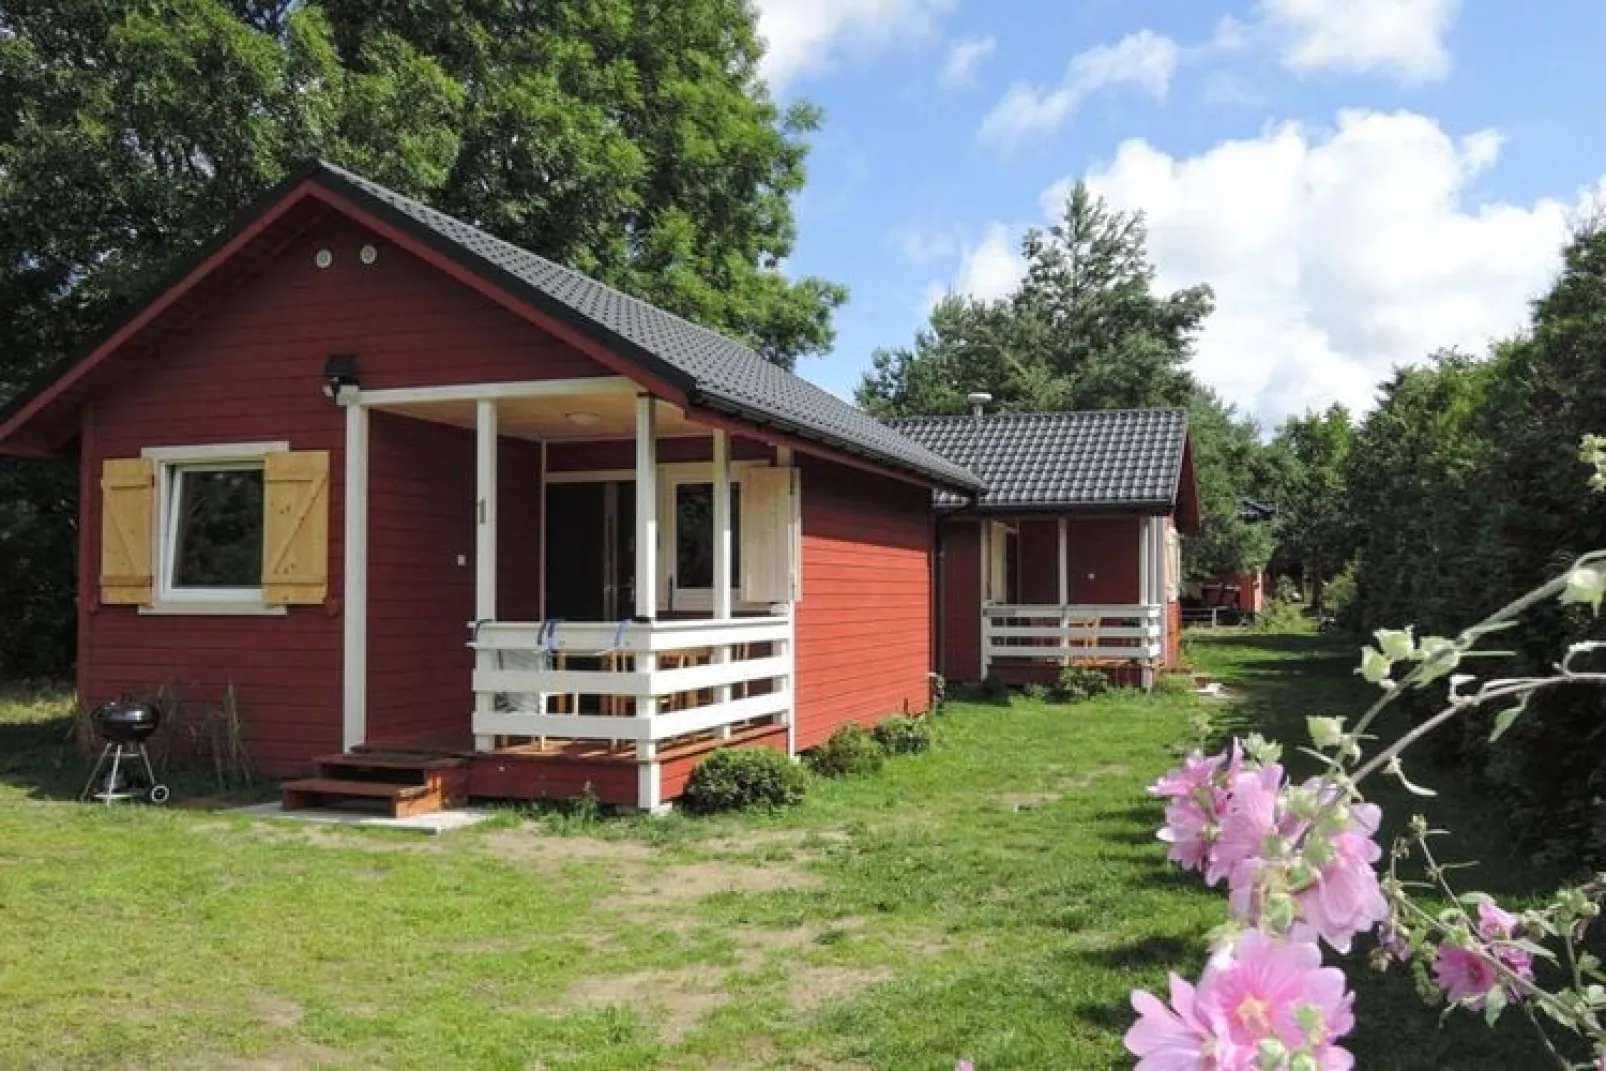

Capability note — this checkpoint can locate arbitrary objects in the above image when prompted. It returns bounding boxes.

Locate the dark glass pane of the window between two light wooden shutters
[172,469,262,588]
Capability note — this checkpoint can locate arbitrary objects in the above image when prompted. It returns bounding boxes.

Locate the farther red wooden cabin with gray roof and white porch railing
[893,409,1200,687]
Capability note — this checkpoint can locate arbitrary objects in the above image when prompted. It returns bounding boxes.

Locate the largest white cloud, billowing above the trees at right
[1072,111,1580,424]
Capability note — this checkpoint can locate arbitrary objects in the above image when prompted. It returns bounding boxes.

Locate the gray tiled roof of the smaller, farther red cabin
[890,409,1188,511]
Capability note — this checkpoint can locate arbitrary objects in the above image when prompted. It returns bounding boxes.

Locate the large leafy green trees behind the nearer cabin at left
[0,0,845,668]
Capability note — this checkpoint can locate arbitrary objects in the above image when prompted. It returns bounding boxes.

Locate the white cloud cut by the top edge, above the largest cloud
[1257,0,1460,82]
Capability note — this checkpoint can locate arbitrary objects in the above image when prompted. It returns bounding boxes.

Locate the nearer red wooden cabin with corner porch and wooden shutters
[0,165,981,809]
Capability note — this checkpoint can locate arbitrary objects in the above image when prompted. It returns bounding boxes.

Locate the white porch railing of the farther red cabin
[981,602,1164,670]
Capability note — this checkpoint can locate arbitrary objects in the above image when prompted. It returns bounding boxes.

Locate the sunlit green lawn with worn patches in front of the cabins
[0,634,1554,1071]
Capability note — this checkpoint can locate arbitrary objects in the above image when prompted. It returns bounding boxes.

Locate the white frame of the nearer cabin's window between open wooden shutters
[140,442,291,617]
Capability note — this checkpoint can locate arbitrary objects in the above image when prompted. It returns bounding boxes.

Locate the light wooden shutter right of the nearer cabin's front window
[262,450,329,605]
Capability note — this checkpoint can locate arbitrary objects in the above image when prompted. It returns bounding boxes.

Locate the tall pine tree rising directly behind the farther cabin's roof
[858,185,1270,578]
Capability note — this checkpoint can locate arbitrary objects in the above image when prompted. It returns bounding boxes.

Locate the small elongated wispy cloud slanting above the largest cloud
[978,31,1182,146]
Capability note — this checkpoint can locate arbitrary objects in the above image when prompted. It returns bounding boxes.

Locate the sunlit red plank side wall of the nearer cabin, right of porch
[795,456,931,750]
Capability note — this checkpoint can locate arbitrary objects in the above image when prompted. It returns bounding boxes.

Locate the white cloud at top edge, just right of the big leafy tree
[756,0,954,93]
